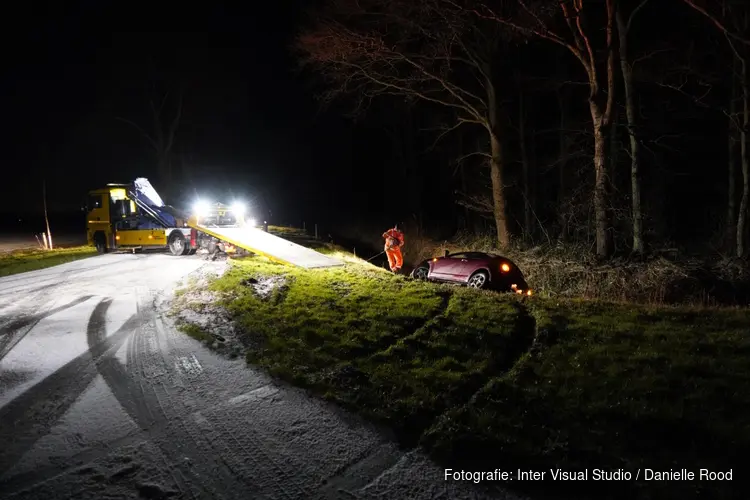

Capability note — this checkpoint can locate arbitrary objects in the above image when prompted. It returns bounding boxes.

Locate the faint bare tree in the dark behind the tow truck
[116,90,183,185]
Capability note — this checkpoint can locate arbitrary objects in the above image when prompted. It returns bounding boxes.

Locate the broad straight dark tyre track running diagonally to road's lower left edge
[0,299,136,484]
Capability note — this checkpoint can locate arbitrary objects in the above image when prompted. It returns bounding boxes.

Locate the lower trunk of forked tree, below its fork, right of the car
[589,98,611,258]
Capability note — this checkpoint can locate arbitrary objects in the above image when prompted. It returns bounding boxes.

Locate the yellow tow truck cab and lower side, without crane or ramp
[86,184,191,253]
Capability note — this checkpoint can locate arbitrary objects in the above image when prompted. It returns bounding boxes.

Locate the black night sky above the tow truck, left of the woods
[0,0,368,227]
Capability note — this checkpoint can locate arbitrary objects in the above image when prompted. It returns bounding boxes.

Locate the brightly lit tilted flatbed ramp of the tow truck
[188,222,344,269]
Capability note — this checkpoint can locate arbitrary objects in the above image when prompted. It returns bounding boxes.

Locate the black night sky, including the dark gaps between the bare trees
[0,0,740,245]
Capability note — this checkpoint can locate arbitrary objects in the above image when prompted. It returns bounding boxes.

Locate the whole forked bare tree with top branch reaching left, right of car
[464,0,616,257]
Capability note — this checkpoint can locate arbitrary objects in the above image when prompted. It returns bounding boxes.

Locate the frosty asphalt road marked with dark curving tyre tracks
[0,254,515,500]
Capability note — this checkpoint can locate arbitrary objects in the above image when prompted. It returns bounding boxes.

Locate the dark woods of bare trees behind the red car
[295,0,750,258]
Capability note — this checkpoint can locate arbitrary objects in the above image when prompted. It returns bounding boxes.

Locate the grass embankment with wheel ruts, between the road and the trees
[203,258,750,498]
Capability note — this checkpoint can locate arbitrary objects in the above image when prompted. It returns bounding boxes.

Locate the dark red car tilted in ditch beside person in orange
[411,251,532,295]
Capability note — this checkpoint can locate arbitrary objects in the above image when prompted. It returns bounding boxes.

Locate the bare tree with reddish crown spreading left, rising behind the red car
[296,0,510,247]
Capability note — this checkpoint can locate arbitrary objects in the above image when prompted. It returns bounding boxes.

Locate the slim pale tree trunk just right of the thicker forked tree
[616,9,645,254]
